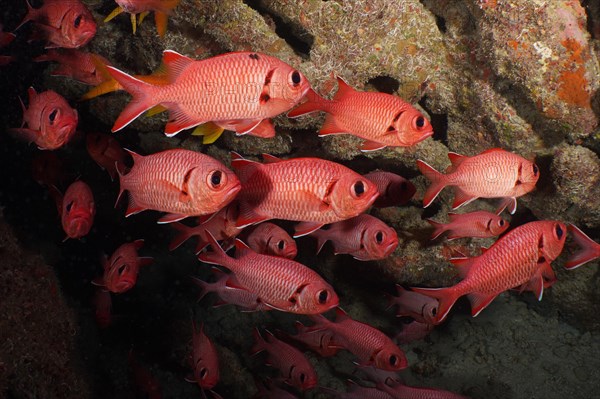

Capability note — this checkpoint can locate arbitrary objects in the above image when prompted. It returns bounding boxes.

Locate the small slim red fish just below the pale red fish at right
[427,211,509,240]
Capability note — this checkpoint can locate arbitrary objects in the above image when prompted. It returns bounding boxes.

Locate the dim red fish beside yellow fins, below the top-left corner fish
[33,49,110,86]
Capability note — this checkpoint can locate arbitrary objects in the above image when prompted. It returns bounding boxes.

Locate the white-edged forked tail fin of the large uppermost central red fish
[106,66,159,132]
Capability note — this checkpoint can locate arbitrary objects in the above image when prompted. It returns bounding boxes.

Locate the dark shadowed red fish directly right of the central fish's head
[363,170,417,208]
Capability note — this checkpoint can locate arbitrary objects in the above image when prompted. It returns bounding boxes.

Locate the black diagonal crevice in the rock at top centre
[244,0,315,58]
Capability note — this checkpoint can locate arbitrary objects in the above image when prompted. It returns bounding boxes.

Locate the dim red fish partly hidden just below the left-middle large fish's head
[169,201,242,253]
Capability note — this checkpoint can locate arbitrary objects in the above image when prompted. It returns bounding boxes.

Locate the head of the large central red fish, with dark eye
[328,172,379,219]
